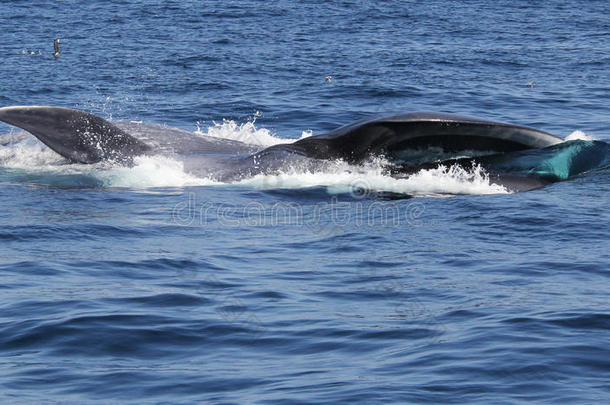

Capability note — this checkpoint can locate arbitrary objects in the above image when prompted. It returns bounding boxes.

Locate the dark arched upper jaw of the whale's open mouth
[276,113,562,162]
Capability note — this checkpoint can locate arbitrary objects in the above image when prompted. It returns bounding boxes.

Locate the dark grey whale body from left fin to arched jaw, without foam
[0,106,562,191]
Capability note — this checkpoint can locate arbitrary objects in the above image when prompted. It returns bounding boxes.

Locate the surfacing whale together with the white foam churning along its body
[0,106,609,196]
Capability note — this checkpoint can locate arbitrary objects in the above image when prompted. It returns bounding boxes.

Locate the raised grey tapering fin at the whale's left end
[0,106,151,163]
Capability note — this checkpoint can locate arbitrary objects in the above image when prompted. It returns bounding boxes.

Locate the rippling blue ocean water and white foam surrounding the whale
[0,0,610,404]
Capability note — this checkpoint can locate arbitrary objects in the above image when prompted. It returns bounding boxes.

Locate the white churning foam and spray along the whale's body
[0,127,507,196]
